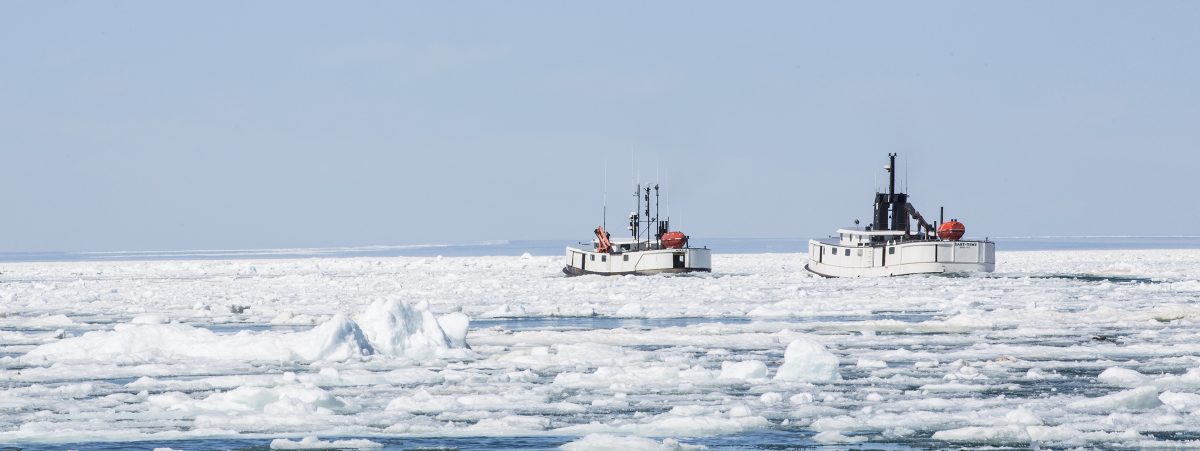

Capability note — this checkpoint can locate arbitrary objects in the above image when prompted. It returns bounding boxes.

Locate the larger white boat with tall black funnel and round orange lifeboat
[804,154,996,277]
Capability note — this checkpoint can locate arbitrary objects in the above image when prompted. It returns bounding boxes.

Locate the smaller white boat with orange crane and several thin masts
[563,185,713,276]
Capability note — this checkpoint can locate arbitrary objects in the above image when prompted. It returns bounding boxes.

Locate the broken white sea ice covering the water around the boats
[0,249,1200,450]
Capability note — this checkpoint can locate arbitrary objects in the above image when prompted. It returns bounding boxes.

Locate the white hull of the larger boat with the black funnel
[804,240,996,277]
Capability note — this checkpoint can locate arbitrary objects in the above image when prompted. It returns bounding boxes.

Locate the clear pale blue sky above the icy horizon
[0,1,1200,252]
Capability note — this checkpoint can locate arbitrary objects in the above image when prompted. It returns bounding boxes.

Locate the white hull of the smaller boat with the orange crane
[563,247,713,276]
